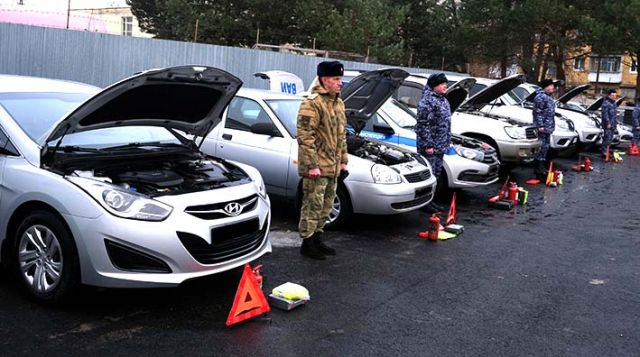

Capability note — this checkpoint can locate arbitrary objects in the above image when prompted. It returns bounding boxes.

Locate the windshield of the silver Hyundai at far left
[0,93,91,144]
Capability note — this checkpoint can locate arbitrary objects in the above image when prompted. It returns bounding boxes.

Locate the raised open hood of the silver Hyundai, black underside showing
[45,66,242,143]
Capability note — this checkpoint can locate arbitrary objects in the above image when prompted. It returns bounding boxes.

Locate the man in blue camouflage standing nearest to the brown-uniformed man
[415,73,451,211]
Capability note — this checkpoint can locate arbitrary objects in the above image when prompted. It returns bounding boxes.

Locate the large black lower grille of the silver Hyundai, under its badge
[177,217,268,264]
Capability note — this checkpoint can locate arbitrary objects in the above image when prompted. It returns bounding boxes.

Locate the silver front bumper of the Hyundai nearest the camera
[65,185,272,288]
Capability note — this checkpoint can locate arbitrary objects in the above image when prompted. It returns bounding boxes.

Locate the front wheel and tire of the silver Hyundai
[12,211,80,304]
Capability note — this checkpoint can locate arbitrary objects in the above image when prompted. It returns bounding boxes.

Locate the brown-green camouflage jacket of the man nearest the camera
[297,83,349,177]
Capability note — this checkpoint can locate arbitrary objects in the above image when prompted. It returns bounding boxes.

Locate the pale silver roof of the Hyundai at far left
[0,74,101,94]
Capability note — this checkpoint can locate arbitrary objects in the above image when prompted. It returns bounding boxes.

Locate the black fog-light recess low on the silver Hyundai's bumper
[104,239,171,273]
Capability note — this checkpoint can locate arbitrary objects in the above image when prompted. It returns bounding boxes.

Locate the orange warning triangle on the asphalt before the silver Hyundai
[227,263,271,326]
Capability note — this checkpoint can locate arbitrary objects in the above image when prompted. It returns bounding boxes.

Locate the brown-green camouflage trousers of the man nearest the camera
[298,177,338,239]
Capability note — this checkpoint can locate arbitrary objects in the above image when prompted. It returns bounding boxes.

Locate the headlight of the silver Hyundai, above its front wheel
[67,176,173,222]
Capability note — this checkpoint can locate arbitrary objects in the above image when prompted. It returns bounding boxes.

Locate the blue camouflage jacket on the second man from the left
[416,87,451,155]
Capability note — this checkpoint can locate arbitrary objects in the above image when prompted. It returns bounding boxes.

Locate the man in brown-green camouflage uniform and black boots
[297,61,348,260]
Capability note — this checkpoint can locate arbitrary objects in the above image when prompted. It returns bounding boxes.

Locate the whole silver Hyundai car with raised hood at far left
[0,66,271,303]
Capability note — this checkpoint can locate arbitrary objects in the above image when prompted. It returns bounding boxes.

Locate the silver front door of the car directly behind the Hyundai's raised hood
[215,96,293,196]
